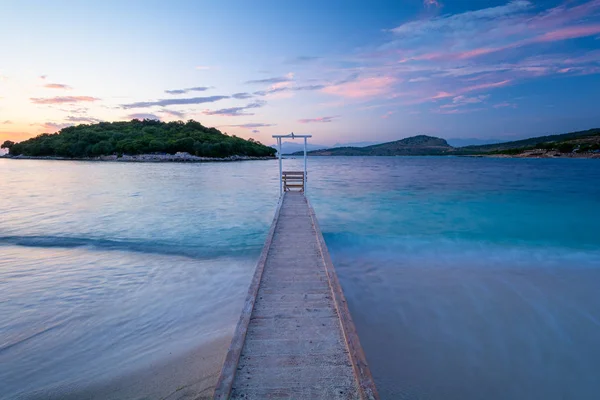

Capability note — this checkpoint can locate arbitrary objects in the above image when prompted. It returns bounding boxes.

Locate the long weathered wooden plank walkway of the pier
[214,191,378,400]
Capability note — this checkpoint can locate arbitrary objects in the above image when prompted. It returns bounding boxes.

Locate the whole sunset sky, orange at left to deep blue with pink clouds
[0,0,600,145]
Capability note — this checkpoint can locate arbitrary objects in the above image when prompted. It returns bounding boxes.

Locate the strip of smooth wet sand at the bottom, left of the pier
[27,336,231,400]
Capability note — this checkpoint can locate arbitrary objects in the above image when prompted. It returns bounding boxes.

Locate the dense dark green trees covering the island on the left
[2,119,276,158]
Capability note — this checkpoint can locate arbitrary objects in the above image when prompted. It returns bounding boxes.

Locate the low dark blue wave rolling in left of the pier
[0,236,255,259]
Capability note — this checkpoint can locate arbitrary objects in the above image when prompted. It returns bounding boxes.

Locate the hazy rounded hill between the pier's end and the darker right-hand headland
[294,135,453,156]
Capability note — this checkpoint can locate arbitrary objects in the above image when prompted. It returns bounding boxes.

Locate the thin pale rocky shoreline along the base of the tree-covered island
[0,152,274,163]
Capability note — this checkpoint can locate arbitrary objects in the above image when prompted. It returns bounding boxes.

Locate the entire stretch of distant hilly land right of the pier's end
[291,129,600,158]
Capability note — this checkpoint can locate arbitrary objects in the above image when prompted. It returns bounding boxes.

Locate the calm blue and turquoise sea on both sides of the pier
[0,157,600,399]
